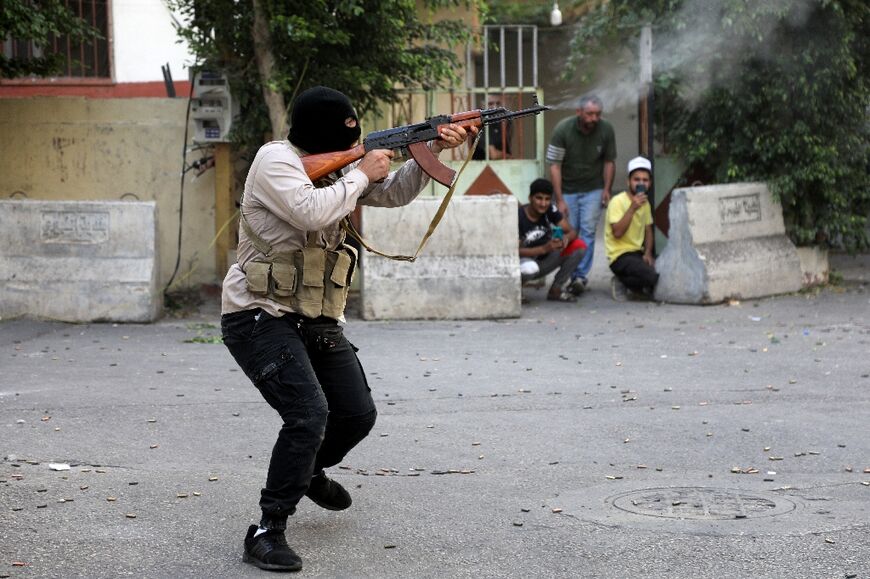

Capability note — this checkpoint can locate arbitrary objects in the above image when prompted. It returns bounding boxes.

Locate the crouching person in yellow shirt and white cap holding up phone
[604,157,659,301]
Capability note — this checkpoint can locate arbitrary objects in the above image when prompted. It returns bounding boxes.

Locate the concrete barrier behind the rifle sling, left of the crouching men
[362,195,521,320]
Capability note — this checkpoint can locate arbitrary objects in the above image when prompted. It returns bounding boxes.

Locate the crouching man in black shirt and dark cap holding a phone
[519,179,586,302]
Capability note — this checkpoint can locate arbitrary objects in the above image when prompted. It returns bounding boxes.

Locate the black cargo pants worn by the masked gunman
[221,309,377,529]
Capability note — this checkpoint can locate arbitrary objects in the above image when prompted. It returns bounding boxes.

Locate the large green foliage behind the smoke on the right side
[573,0,870,251]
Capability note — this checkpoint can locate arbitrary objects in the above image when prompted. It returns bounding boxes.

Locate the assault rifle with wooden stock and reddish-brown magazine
[302,97,550,187]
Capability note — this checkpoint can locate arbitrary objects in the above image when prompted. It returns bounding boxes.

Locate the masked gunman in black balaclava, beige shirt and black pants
[221,87,476,571]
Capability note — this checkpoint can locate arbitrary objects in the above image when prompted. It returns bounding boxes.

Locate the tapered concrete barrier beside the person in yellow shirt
[655,183,802,304]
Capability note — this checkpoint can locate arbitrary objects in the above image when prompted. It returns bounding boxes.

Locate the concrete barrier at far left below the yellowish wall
[0,200,163,322]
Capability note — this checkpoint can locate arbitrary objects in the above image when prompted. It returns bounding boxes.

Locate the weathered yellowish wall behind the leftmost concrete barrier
[0,97,219,294]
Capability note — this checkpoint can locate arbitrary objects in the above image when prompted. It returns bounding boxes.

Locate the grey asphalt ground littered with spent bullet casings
[0,268,870,578]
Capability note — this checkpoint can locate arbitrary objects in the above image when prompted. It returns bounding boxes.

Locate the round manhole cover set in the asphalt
[609,487,795,521]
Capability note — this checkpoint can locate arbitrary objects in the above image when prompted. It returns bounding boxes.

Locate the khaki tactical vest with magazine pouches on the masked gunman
[240,214,357,319]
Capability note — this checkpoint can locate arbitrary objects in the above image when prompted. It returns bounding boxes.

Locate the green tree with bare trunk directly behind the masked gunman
[169,0,474,156]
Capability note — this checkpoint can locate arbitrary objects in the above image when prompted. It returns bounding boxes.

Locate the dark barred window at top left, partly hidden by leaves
[2,0,112,80]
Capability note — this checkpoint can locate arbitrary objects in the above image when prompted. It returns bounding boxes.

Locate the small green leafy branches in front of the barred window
[0,0,99,78]
